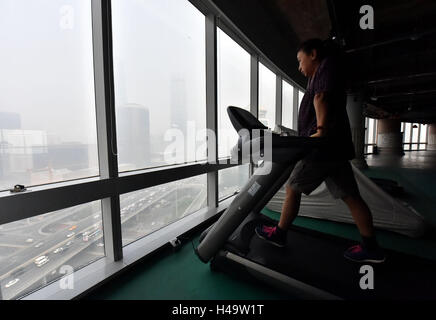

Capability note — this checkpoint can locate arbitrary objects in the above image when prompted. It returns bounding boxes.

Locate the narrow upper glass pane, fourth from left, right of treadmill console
[259,63,276,129]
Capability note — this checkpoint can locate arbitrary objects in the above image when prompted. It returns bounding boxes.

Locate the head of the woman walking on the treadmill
[297,39,326,77]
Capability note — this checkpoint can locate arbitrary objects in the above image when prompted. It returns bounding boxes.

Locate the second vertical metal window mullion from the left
[205,14,218,208]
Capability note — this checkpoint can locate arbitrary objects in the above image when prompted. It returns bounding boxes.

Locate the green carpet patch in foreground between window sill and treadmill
[86,235,292,300]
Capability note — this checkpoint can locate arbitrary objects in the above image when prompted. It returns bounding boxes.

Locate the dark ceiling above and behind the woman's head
[214,0,436,123]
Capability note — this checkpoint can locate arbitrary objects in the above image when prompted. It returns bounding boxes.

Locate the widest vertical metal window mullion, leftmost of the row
[91,0,123,261]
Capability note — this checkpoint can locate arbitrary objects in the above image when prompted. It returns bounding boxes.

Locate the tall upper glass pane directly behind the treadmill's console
[217,29,251,158]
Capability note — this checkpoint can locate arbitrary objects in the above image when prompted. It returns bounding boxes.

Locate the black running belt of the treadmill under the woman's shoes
[220,212,436,299]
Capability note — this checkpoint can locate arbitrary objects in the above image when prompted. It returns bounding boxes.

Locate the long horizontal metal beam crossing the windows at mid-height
[0,163,236,225]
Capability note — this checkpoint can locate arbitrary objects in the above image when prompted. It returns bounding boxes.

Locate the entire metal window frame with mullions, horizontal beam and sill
[0,0,304,300]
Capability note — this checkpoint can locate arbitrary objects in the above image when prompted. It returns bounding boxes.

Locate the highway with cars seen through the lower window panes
[0,178,207,300]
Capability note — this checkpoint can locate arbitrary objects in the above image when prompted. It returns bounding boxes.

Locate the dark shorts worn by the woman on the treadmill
[287,159,360,199]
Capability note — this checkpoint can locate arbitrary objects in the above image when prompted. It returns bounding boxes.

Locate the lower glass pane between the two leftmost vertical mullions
[120,174,207,246]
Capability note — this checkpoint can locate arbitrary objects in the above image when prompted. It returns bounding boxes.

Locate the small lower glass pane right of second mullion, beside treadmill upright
[218,164,250,200]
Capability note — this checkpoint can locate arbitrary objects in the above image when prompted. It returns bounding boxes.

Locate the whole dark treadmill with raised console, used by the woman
[195,107,436,300]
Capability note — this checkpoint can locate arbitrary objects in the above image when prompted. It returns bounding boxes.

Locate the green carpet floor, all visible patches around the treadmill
[86,162,436,300]
